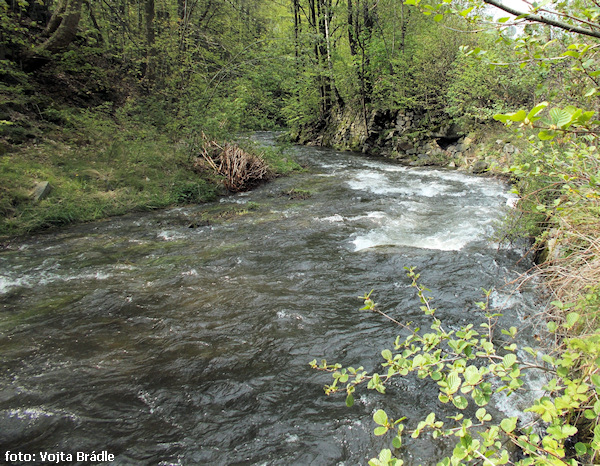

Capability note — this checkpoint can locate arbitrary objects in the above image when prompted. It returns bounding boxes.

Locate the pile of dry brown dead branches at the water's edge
[194,137,273,192]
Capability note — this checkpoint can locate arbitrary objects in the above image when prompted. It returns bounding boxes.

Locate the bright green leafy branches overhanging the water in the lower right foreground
[311,268,600,466]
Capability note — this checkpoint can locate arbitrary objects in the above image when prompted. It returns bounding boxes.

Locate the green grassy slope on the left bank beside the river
[0,112,296,238]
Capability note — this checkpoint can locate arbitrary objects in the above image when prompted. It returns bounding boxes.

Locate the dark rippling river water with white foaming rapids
[0,133,544,465]
